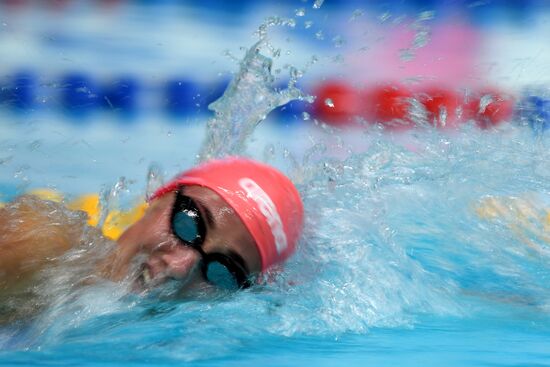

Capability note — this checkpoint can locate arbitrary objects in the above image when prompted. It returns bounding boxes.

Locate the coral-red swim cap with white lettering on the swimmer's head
[151,157,304,271]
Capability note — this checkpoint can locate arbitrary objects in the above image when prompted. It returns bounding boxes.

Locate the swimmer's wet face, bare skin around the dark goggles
[113,186,261,294]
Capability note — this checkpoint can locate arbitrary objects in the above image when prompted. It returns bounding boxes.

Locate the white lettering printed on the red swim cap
[239,177,287,254]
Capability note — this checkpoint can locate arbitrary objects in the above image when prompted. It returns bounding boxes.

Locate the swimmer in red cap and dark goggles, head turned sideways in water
[0,158,303,322]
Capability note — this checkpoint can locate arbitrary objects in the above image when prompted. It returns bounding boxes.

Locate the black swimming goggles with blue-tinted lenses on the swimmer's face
[171,188,251,289]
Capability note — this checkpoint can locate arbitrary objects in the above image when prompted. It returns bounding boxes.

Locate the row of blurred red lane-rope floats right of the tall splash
[313,80,515,130]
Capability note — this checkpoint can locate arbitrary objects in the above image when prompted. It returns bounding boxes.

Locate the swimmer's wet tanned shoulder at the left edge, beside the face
[0,195,98,324]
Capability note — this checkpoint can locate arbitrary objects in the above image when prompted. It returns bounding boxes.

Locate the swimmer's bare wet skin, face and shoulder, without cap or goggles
[0,186,261,325]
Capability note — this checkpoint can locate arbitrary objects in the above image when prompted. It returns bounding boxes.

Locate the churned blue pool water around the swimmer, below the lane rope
[0,115,550,366]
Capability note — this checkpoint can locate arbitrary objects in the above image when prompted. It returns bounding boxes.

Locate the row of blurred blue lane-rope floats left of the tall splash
[0,71,233,121]
